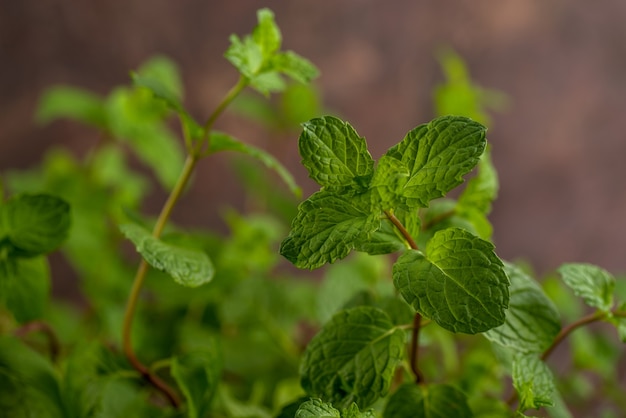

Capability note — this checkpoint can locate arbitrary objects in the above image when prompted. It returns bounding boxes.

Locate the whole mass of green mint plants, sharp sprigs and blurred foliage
[0,9,626,418]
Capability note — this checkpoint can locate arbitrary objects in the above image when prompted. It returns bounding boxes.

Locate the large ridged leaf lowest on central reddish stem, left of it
[300,307,405,408]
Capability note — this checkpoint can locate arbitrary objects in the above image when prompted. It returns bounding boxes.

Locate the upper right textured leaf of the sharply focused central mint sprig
[386,116,486,207]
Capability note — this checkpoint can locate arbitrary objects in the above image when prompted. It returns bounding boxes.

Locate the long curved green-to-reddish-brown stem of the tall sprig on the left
[122,76,249,408]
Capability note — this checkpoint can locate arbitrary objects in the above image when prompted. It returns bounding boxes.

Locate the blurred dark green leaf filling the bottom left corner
[0,336,66,418]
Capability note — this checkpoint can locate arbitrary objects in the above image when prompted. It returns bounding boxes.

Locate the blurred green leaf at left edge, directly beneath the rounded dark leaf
[0,257,50,323]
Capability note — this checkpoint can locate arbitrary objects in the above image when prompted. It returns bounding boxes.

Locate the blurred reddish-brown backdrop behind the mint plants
[0,0,626,273]
